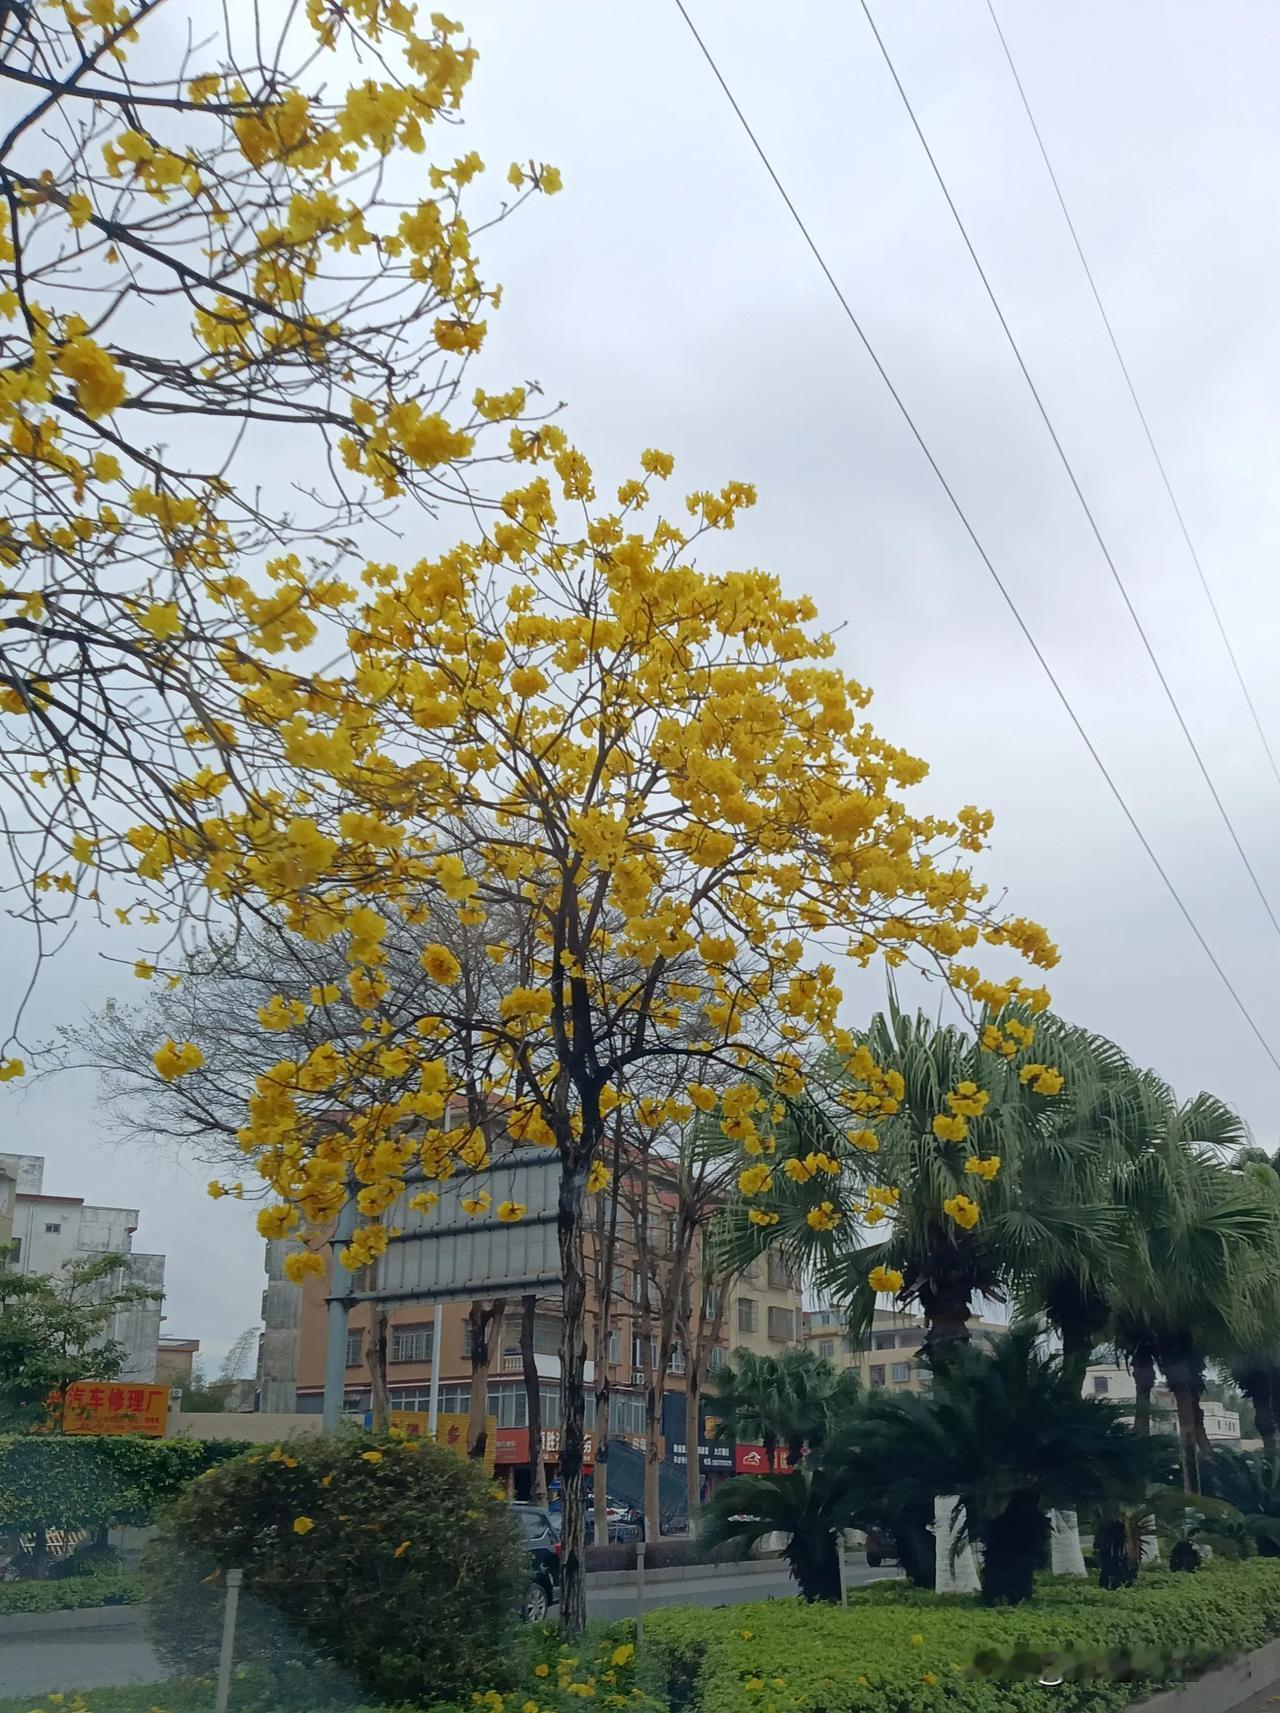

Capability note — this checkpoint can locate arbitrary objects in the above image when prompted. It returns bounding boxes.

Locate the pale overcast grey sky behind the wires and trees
[5,0,1280,1357]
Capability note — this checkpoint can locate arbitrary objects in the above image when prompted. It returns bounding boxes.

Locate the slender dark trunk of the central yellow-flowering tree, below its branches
[555,1148,589,1636]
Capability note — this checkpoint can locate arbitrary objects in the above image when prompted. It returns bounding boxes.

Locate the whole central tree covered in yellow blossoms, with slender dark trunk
[117,427,1054,1627]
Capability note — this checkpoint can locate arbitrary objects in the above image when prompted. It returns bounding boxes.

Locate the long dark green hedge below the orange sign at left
[0,1434,247,1533]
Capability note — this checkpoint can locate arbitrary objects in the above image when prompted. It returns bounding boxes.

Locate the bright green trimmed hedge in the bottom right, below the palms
[643,1559,1280,1713]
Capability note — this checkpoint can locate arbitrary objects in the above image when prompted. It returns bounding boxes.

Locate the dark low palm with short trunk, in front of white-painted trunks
[870,1326,1157,1605]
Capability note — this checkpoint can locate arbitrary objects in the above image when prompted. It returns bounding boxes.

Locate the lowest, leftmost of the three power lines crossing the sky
[675,0,1280,1071]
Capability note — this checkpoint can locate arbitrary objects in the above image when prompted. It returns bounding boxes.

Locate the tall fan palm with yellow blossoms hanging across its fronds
[727,1004,1122,1350]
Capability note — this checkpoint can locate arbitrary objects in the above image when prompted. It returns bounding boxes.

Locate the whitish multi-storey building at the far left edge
[0,1155,164,1382]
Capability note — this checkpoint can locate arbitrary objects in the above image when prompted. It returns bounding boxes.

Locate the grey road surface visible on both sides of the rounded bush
[0,1561,897,1713]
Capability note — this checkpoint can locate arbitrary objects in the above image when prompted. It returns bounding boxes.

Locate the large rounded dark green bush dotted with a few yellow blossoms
[144,1434,528,1704]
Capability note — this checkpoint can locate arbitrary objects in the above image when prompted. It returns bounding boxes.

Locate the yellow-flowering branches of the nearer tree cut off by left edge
[0,0,559,1041]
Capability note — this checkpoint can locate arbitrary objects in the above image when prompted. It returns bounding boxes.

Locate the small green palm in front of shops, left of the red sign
[708,1348,858,1468]
